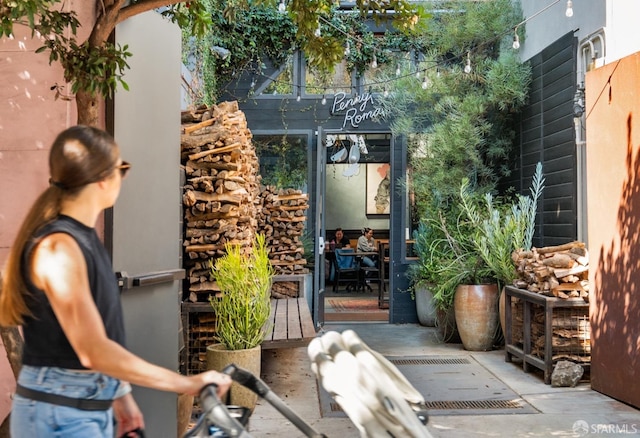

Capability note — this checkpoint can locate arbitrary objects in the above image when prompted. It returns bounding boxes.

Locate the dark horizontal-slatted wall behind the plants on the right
[502,32,578,247]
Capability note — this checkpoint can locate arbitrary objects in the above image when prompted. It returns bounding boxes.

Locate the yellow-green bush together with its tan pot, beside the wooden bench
[207,234,274,409]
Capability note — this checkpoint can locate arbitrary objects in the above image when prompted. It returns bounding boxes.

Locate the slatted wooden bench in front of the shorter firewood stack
[262,297,316,350]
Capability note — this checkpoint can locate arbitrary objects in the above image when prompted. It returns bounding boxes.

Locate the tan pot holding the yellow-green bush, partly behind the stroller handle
[207,344,261,411]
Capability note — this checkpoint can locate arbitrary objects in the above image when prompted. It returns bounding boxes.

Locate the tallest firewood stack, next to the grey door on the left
[181,102,262,302]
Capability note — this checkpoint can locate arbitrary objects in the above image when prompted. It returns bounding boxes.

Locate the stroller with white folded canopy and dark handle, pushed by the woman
[184,330,431,438]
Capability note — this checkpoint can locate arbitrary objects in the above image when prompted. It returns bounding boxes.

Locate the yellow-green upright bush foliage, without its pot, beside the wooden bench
[209,234,274,350]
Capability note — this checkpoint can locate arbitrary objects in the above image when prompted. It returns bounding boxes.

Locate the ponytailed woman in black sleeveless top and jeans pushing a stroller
[0,126,231,438]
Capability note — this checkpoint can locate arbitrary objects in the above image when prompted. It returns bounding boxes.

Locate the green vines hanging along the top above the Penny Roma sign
[183,0,423,104]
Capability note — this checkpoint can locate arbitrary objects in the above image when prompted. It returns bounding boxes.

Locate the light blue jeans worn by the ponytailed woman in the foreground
[11,365,119,438]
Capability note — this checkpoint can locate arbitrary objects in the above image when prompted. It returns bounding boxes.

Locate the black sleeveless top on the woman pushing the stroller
[22,215,124,369]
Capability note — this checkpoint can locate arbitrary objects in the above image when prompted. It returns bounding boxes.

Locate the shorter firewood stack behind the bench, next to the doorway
[258,186,309,275]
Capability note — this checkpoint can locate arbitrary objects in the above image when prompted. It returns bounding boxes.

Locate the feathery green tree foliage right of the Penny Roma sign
[381,0,531,224]
